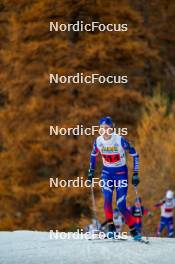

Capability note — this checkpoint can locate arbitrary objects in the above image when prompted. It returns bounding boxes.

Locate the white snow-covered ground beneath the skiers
[0,231,175,264]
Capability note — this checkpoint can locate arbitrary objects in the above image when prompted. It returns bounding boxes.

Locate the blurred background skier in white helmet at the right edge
[155,190,175,237]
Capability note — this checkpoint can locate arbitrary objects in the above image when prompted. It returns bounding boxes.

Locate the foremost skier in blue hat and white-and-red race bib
[88,116,141,240]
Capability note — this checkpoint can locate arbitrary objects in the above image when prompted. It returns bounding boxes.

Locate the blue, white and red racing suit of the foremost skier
[90,133,139,227]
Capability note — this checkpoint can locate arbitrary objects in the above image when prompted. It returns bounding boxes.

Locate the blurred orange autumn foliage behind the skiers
[0,0,175,233]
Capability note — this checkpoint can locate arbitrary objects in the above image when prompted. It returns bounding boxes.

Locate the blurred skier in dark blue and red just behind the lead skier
[128,197,153,234]
